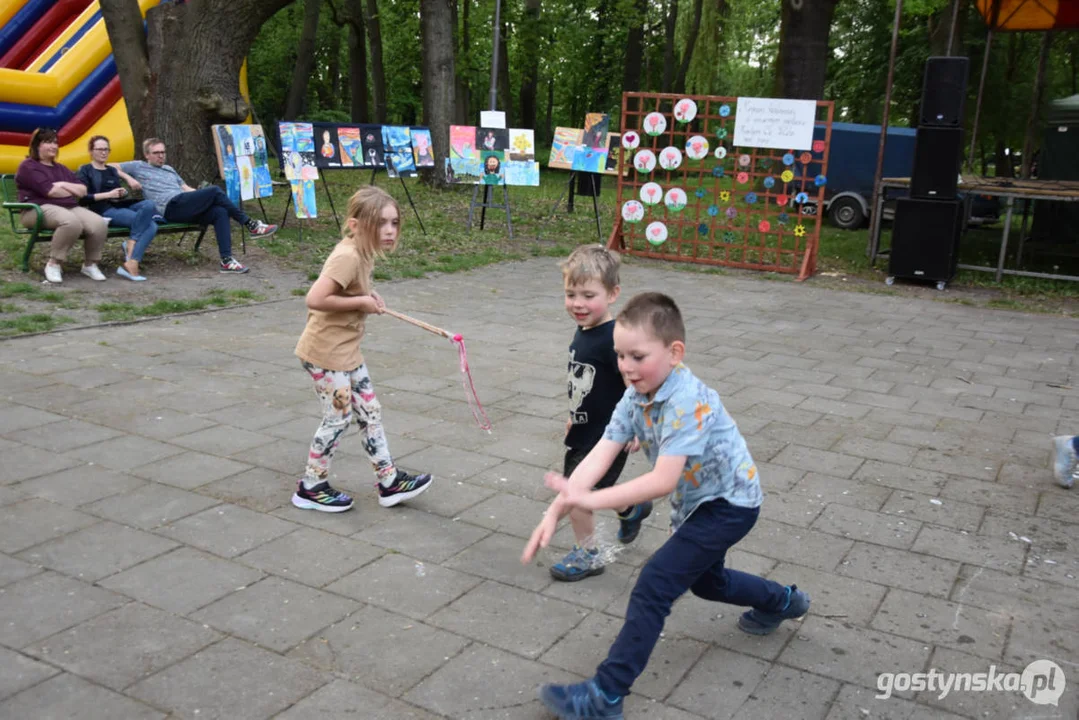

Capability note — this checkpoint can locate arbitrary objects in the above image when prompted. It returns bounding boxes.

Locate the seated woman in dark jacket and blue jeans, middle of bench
[78,135,160,282]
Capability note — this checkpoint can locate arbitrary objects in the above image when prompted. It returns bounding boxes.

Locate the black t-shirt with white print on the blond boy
[565,320,626,450]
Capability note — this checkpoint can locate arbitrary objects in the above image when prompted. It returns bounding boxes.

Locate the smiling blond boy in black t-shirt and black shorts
[550,245,652,582]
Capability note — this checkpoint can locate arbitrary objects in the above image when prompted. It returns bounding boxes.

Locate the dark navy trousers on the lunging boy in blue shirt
[596,500,787,695]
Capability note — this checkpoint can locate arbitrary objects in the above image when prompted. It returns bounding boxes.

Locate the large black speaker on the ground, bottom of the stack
[888,198,962,283]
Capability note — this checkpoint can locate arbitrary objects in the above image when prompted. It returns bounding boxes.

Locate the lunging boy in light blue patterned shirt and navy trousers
[521,293,809,720]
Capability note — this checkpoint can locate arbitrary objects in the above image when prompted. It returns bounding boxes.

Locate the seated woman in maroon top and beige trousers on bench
[15,127,109,283]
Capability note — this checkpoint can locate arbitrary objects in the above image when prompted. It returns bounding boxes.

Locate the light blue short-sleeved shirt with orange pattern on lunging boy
[603,365,764,529]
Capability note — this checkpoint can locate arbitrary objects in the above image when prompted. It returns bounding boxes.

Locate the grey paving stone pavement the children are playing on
[0,259,1079,720]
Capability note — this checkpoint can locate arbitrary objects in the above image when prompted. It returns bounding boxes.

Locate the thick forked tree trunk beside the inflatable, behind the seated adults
[100,0,290,185]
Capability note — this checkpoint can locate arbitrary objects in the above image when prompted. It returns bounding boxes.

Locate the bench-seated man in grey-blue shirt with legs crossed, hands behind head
[117,137,277,273]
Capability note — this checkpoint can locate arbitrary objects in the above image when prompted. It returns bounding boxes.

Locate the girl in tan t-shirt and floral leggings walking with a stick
[292,187,432,513]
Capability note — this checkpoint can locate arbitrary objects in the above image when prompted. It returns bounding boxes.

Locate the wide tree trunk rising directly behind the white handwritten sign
[773,0,837,99]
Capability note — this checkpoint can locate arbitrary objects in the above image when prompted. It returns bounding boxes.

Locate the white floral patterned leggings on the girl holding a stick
[303,362,397,488]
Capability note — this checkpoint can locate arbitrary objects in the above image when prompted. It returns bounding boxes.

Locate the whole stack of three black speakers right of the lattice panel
[885,57,968,290]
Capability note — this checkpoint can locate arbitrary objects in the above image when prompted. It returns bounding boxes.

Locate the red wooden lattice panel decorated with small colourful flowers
[609,93,834,280]
